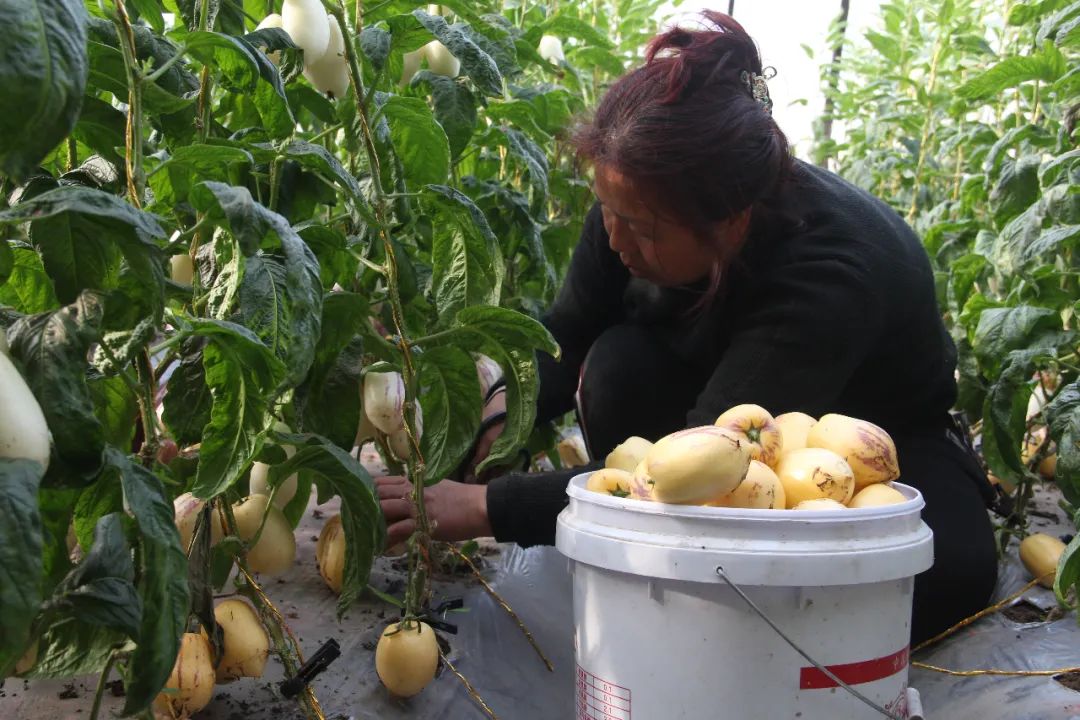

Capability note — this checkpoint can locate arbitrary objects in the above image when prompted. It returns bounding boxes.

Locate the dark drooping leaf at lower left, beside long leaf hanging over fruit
[46,513,143,638]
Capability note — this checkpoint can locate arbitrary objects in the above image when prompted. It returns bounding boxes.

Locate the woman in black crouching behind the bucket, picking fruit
[378,13,997,642]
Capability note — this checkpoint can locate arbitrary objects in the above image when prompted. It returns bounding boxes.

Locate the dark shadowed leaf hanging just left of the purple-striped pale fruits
[296,293,370,450]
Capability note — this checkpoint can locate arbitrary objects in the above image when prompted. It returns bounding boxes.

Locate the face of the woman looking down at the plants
[593,165,730,286]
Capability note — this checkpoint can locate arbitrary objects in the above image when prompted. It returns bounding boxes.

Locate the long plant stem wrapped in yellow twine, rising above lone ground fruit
[324,0,431,621]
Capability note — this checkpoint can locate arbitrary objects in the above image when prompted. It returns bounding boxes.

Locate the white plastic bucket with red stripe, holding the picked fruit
[556,474,933,720]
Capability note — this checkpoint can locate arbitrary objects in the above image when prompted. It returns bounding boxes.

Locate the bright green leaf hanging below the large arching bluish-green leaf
[176,317,285,500]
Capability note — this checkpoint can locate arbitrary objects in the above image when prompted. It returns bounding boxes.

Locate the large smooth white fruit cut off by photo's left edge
[0,353,53,471]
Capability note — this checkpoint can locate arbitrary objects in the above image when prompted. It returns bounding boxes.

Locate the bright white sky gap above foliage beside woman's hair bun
[658,0,881,158]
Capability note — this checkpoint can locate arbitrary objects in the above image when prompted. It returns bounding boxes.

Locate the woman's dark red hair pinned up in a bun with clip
[575,11,792,284]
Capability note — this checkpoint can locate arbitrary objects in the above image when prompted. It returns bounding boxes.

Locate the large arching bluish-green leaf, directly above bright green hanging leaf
[194,182,323,386]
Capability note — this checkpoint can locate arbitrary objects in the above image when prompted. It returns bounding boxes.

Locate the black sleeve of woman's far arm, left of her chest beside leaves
[537,203,630,423]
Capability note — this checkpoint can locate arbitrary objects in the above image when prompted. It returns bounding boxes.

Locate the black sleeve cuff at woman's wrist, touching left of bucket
[487,461,604,547]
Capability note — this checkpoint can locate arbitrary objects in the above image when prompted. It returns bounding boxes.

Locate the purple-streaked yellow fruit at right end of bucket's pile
[807,413,900,489]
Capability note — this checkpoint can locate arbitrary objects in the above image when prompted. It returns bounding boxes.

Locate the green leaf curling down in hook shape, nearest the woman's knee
[441,307,559,472]
